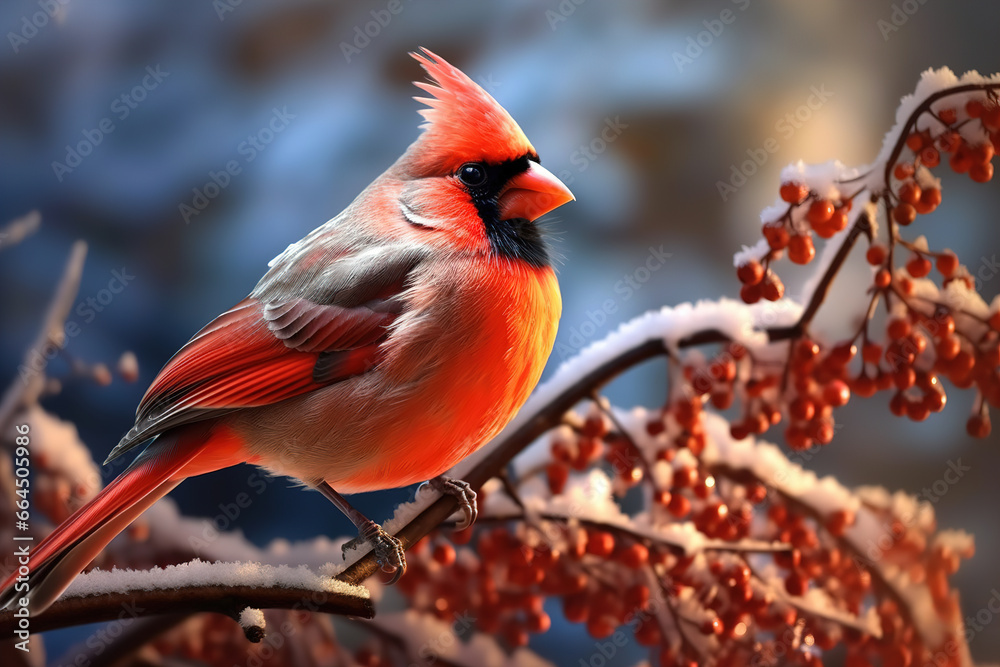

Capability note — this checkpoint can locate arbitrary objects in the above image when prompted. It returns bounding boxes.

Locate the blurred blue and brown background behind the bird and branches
[0,0,1000,664]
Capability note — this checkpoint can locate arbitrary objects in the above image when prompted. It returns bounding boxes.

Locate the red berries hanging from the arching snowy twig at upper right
[732,94,1000,440]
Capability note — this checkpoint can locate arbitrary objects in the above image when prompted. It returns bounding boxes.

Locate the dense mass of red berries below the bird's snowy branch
[373,386,971,667]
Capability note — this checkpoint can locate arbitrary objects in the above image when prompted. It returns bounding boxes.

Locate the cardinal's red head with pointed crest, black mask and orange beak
[389,49,574,266]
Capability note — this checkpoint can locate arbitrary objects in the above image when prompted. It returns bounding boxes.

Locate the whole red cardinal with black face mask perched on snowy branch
[0,50,573,613]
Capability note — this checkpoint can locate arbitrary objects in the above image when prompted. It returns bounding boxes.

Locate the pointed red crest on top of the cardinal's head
[410,49,535,172]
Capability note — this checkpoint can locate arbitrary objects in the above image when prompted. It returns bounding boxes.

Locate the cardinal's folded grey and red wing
[105,240,421,463]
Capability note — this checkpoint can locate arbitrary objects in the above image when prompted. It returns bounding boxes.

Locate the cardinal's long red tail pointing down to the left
[0,424,243,614]
